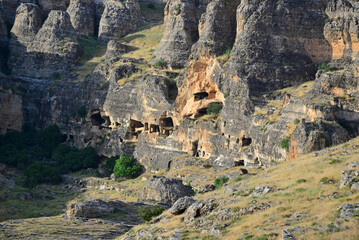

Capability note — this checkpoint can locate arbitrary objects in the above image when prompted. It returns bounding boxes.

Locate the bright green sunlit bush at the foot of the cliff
[113,154,142,178]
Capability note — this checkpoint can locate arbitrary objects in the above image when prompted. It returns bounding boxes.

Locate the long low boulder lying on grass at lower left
[66,199,115,218]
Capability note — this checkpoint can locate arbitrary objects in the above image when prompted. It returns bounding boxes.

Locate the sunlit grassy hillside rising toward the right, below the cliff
[119,138,359,240]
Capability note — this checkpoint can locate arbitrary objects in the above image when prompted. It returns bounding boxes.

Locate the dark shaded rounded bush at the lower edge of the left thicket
[24,162,61,188]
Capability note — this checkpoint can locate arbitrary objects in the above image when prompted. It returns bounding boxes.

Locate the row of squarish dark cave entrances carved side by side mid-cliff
[129,112,174,140]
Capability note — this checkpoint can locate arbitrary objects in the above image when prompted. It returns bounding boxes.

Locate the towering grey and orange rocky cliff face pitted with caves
[3,0,359,169]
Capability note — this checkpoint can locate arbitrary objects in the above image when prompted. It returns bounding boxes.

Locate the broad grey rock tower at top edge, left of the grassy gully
[98,0,143,41]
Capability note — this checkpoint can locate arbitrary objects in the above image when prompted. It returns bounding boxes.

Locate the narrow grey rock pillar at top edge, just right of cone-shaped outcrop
[66,0,95,36]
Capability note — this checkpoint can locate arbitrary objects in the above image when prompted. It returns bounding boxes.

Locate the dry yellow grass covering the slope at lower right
[119,138,359,240]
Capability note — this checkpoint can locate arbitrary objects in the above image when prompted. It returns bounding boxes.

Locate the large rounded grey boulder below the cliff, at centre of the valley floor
[140,177,194,205]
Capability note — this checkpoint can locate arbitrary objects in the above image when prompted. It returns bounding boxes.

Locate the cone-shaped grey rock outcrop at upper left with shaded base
[11,11,81,78]
